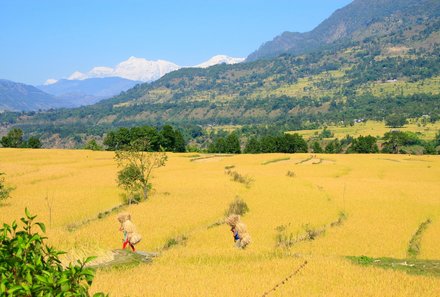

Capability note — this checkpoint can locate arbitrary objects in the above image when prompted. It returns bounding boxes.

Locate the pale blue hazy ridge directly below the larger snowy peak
[37,77,141,106]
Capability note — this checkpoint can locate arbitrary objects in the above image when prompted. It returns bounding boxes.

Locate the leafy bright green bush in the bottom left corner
[0,209,104,296]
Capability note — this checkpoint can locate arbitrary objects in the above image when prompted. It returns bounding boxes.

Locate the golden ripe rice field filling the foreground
[0,149,440,297]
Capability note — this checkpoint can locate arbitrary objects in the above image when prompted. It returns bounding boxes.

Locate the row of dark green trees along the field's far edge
[0,122,440,154]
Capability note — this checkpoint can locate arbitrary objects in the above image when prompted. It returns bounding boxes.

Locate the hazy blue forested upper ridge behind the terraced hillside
[247,0,440,61]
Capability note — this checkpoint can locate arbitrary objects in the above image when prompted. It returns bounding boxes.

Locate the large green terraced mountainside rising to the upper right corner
[0,0,440,145]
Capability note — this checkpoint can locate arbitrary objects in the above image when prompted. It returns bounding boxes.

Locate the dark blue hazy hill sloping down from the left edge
[0,79,70,111]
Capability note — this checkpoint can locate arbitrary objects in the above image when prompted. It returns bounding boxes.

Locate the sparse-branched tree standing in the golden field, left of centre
[115,139,167,204]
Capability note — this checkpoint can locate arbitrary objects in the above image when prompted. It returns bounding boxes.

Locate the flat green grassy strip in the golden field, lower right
[346,256,440,277]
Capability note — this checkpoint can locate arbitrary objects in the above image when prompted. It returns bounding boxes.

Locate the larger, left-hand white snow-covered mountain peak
[68,57,181,82]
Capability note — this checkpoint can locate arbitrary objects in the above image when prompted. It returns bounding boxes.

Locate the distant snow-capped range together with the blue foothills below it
[0,55,244,111]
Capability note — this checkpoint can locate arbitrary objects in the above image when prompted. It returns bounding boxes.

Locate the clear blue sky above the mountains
[0,0,351,84]
